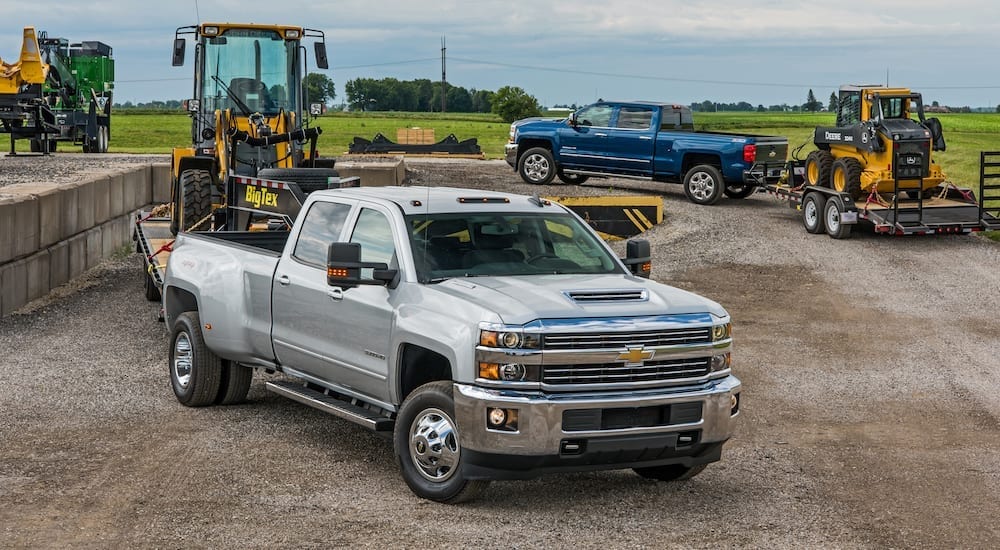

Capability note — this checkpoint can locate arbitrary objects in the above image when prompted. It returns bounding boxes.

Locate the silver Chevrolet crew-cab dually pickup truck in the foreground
[162,187,740,502]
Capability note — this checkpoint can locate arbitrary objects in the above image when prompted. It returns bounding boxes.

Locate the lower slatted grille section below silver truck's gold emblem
[542,358,711,386]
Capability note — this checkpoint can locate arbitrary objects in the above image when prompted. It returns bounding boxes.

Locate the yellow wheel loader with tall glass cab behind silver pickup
[164,23,339,234]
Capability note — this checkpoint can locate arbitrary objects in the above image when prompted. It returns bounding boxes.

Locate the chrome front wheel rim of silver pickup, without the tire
[409,408,462,483]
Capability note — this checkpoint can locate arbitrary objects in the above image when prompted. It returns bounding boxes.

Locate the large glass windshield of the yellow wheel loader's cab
[201,29,298,116]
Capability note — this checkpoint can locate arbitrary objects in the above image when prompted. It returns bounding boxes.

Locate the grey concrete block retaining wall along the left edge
[0,164,170,317]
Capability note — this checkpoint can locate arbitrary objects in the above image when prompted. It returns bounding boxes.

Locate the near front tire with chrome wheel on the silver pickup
[393,380,489,504]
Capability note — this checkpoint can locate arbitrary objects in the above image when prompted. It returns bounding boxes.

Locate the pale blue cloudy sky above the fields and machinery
[0,0,1000,107]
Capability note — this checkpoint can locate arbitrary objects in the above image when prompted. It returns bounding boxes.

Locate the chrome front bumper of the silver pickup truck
[454,375,741,467]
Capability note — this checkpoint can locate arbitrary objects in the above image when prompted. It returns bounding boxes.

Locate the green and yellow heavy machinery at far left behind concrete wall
[0,27,115,154]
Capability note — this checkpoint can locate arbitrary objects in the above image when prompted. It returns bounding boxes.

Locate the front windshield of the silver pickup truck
[407,213,624,282]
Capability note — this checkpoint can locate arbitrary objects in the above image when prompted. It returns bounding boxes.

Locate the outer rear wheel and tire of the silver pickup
[169,311,222,407]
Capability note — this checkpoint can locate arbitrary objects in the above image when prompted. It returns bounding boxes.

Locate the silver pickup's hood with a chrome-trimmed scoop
[435,275,727,325]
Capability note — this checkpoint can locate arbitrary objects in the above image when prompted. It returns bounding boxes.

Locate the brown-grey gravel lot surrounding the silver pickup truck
[0,155,1000,548]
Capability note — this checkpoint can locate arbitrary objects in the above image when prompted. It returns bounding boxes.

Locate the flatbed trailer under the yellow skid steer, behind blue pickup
[762,152,1000,239]
